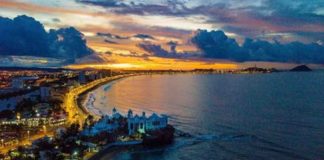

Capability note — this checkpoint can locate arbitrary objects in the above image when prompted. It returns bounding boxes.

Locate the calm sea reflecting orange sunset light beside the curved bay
[90,72,324,160]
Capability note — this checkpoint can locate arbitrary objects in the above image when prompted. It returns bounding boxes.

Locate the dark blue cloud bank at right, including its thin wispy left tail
[138,30,324,64]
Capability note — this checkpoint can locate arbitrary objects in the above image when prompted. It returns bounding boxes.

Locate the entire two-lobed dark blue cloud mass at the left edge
[0,15,93,61]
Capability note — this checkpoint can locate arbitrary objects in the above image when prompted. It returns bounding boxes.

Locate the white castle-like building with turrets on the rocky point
[127,110,168,135]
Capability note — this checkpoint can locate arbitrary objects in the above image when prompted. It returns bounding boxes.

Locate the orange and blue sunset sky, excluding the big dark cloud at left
[0,0,324,69]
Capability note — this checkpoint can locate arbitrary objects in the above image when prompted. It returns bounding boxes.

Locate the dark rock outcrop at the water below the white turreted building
[143,125,175,146]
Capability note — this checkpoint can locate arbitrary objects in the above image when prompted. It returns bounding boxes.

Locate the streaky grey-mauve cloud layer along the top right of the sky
[79,0,324,42]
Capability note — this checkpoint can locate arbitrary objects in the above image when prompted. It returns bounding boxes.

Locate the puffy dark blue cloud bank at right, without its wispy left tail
[192,30,324,64]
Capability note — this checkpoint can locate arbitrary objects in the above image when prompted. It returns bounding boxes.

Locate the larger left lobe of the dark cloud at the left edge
[0,16,49,56]
